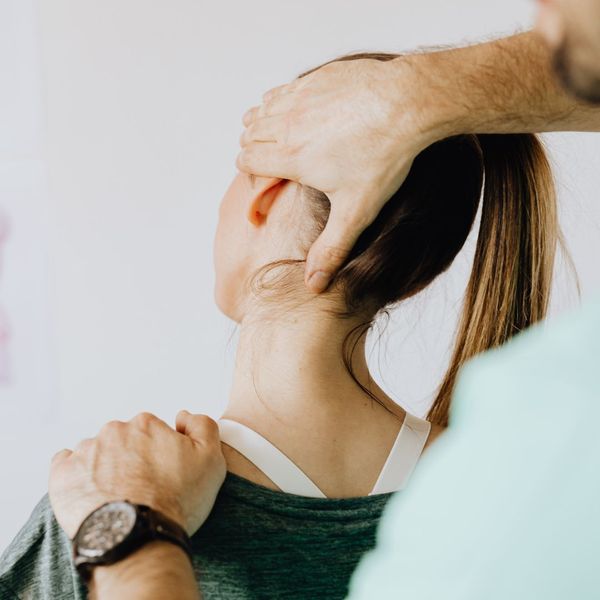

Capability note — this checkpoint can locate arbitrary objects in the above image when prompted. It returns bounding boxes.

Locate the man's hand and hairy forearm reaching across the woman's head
[237,30,600,292]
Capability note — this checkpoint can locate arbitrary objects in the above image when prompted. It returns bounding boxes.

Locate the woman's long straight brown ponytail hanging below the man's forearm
[427,134,559,426]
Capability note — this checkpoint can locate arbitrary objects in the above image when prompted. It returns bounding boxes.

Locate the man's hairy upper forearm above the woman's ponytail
[398,32,600,139]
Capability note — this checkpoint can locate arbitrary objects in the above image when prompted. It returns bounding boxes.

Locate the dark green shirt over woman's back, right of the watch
[192,473,390,600]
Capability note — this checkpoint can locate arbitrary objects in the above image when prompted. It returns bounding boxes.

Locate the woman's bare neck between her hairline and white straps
[226,308,385,427]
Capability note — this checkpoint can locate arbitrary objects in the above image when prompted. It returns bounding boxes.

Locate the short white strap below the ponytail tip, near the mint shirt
[369,413,431,496]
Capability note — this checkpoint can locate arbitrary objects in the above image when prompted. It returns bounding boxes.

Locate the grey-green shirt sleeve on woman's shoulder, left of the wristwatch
[0,495,83,600]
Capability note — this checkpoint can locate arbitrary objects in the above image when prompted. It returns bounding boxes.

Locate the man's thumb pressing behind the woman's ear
[305,203,369,294]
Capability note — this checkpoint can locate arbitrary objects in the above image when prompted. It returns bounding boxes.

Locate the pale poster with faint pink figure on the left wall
[0,160,57,422]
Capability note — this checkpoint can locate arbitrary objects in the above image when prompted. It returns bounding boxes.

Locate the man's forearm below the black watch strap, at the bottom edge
[90,542,200,600]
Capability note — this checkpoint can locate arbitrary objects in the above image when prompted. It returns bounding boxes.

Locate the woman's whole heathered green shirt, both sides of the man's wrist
[0,473,390,600]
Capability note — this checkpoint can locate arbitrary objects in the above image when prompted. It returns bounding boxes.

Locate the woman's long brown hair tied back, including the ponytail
[260,53,559,425]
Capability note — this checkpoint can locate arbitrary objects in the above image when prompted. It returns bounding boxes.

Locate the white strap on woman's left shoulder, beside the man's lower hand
[218,419,326,498]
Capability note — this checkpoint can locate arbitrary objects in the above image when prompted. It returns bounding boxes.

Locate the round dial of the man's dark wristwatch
[75,502,137,557]
